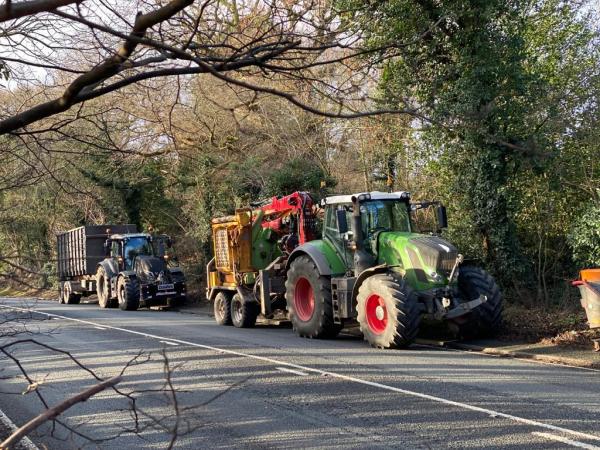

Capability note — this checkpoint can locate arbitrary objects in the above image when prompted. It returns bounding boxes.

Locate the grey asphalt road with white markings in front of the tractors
[0,298,600,449]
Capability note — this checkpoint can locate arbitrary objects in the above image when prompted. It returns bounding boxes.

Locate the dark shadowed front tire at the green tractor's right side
[455,266,502,339]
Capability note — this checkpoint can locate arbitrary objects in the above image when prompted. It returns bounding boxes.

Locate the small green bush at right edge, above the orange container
[568,204,600,268]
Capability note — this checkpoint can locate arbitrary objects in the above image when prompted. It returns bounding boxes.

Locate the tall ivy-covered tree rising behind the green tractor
[343,0,594,285]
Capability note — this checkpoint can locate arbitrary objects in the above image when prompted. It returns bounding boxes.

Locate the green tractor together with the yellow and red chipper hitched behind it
[207,192,502,348]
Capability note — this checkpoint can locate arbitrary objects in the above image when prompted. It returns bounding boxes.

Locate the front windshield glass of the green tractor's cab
[360,200,410,237]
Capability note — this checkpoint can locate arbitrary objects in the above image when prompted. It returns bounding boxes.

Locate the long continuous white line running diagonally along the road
[0,305,600,442]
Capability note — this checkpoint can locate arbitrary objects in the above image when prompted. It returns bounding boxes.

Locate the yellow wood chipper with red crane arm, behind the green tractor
[206,192,317,327]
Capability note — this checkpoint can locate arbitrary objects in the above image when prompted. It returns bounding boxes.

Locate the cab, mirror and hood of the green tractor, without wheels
[323,192,450,280]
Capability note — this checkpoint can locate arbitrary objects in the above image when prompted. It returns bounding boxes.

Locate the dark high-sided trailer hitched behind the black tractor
[56,225,137,304]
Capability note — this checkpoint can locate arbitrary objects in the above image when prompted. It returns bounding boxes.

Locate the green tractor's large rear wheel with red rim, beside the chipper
[285,256,342,339]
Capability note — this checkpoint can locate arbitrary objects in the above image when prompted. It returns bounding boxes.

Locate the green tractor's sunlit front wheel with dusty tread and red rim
[356,273,421,348]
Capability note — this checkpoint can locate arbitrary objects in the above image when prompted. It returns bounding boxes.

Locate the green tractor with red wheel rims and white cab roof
[285,192,502,348]
